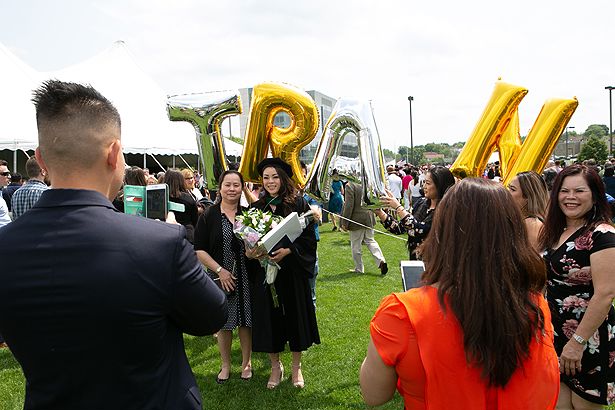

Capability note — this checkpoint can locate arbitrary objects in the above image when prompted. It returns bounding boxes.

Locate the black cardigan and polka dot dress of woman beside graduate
[194,204,252,330]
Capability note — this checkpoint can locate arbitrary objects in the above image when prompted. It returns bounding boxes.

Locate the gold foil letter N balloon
[451,81,578,185]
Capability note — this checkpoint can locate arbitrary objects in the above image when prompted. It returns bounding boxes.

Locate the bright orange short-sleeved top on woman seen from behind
[371,286,559,410]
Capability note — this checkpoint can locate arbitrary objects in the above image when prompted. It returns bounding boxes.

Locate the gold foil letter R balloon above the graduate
[239,83,319,187]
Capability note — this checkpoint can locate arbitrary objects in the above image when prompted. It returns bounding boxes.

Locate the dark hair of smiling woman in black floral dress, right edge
[538,165,611,249]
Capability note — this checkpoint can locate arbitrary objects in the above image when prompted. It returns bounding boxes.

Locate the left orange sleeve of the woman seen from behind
[370,294,414,366]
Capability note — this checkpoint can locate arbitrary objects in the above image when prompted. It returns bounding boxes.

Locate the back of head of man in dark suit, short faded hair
[32,80,121,169]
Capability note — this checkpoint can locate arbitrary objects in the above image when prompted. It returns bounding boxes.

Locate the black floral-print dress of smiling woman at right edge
[545,224,615,404]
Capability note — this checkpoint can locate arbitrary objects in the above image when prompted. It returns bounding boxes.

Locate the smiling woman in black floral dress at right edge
[540,165,615,409]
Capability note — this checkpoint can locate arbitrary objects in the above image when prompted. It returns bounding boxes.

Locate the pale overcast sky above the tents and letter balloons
[0,0,615,149]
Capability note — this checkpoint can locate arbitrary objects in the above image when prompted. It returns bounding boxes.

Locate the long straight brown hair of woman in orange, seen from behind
[423,178,546,387]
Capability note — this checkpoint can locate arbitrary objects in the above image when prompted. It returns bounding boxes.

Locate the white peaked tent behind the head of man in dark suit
[0,41,206,155]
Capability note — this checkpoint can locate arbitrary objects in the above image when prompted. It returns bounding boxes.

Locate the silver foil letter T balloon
[167,91,242,189]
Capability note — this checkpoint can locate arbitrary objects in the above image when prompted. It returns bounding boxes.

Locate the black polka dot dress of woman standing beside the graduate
[222,214,252,330]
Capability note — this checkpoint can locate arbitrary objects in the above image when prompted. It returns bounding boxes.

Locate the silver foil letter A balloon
[306,99,385,209]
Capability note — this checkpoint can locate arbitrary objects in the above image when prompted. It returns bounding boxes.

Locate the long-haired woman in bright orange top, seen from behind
[360,178,559,410]
